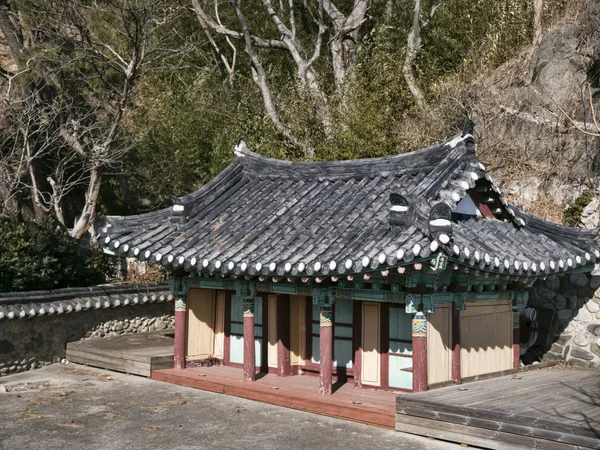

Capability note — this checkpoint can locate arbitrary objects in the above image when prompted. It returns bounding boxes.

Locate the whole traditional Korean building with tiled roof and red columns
[97,130,600,394]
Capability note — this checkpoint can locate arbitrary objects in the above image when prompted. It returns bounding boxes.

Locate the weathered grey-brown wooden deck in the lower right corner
[396,368,600,449]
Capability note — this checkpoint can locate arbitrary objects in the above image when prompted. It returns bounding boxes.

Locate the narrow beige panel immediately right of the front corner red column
[427,303,452,384]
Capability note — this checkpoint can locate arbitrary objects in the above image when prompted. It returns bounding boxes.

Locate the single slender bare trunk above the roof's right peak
[402,0,447,109]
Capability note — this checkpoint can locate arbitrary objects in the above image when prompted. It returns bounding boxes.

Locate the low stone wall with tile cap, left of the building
[0,285,174,376]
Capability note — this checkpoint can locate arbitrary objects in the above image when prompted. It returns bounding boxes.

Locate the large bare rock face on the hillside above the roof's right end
[471,12,600,208]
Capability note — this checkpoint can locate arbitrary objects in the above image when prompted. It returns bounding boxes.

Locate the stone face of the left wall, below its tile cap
[0,302,175,377]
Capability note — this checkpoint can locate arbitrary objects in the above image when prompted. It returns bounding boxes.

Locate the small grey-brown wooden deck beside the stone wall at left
[67,330,173,377]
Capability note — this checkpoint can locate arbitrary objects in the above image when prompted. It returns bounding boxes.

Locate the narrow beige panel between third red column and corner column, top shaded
[361,303,381,386]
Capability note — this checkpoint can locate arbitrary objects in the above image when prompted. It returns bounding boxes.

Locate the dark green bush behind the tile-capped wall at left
[0,219,116,292]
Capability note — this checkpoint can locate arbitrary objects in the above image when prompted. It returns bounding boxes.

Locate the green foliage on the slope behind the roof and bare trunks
[27,0,568,214]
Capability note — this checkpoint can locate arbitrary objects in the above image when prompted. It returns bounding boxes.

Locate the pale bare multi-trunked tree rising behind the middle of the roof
[192,0,370,159]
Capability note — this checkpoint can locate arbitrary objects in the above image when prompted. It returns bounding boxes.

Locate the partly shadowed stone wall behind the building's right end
[521,274,600,367]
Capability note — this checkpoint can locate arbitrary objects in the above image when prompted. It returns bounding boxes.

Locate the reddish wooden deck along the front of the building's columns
[152,366,396,430]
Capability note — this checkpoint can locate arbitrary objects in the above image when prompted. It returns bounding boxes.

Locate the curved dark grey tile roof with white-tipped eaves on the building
[97,134,600,276]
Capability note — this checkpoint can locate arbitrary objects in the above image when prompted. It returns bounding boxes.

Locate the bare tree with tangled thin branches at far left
[0,0,186,239]
